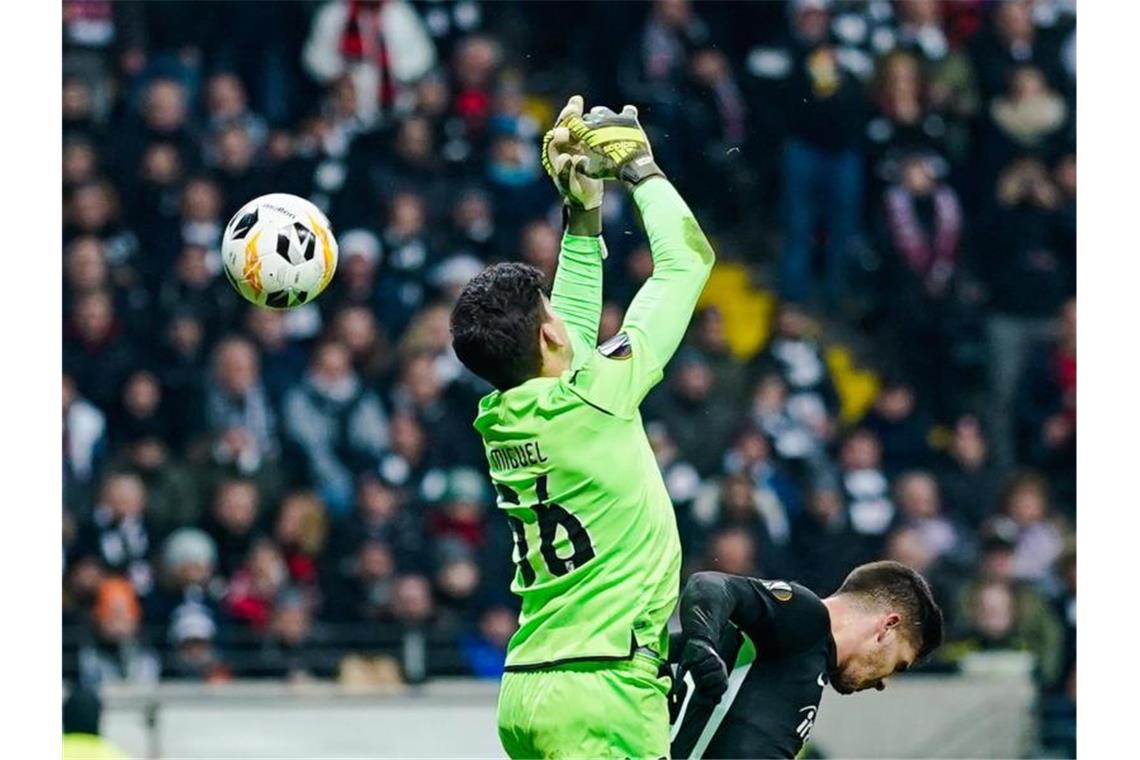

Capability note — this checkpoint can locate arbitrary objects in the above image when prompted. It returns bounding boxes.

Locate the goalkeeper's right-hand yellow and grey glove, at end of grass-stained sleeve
[563,102,665,185]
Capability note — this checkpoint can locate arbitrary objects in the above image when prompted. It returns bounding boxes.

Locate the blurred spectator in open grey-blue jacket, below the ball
[284,342,389,514]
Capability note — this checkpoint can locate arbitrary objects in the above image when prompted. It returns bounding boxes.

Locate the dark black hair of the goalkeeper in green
[451,262,546,391]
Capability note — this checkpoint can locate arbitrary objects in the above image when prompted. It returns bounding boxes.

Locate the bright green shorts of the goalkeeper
[498,653,669,759]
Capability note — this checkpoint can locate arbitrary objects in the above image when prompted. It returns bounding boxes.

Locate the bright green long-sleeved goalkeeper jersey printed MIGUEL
[475,178,714,670]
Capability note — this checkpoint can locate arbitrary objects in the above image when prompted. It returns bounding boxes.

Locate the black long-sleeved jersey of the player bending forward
[669,572,836,758]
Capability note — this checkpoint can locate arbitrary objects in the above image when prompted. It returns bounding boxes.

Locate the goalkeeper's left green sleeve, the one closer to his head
[551,234,604,367]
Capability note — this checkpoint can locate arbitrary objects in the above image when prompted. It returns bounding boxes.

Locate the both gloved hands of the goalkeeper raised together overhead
[543,95,662,211]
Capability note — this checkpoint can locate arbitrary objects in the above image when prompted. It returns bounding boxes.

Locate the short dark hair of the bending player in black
[836,559,943,660]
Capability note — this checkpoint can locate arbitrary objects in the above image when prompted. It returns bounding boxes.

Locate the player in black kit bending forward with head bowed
[669,562,942,758]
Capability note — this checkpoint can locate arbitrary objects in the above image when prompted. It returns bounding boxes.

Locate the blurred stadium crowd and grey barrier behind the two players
[62,0,1076,757]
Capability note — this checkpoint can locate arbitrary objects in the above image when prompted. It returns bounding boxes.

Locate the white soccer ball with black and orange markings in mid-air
[221,193,336,309]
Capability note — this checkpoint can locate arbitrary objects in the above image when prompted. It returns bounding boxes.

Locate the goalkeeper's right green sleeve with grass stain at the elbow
[622,178,716,368]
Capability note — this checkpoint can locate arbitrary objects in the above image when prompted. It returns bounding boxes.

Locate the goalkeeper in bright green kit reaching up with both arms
[451,96,714,758]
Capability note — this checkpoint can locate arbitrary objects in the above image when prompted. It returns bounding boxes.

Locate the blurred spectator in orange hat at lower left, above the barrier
[79,578,162,688]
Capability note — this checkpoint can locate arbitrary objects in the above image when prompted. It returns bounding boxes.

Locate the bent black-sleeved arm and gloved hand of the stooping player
[681,572,770,702]
